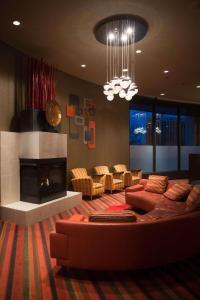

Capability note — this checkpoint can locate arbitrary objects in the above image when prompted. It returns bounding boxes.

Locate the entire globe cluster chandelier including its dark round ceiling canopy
[95,15,147,101]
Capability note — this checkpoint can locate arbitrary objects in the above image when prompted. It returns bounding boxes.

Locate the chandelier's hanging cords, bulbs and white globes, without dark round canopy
[103,21,138,101]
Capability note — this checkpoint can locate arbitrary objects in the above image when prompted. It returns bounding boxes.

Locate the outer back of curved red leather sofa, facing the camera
[50,211,200,270]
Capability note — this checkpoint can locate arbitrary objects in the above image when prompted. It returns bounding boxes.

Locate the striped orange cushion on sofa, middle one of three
[164,183,191,201]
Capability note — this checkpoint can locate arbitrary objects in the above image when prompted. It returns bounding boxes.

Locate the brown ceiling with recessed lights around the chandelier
[0,0,200,103]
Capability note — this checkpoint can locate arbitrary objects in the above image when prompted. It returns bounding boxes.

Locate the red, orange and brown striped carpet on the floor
[0,193,200,300]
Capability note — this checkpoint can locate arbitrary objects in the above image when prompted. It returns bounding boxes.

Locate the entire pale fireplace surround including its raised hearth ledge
[0,131,82,225]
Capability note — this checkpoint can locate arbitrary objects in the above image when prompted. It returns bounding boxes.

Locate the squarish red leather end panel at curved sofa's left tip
[50,232,69,259]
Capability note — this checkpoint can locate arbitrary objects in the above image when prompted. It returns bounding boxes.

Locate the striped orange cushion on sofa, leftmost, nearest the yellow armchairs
[144,175,168,194]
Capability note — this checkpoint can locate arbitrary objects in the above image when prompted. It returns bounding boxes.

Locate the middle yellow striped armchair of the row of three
[94,166,124,193]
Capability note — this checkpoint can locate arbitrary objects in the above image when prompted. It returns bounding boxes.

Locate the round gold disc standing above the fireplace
[45,101,62,127]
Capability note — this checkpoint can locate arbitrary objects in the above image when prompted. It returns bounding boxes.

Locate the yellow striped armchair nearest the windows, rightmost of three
[113,164,142,186]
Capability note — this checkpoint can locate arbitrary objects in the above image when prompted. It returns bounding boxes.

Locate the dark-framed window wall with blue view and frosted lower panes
[130,96,200,172]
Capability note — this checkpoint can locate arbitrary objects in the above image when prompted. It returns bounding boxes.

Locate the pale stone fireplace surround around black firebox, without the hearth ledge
[0,131,67,205]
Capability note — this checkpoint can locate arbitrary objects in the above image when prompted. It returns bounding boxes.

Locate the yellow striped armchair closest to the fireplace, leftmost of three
[71,168,105,200]
